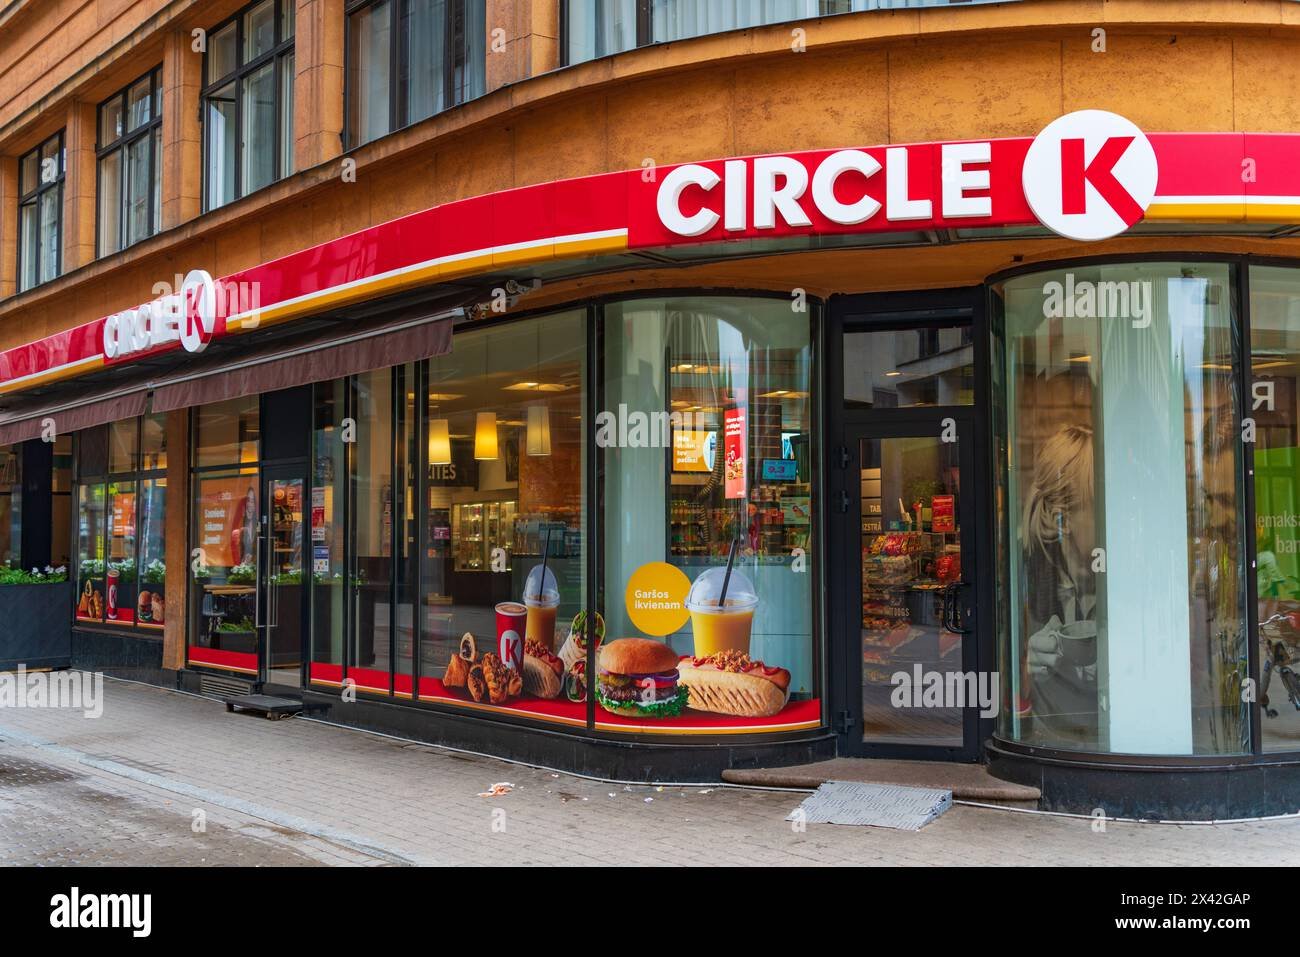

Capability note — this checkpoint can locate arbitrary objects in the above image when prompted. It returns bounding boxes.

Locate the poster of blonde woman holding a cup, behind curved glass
[1017,424,1097,742]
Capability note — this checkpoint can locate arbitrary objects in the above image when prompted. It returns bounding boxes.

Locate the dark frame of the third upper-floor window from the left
[199,0,298,213]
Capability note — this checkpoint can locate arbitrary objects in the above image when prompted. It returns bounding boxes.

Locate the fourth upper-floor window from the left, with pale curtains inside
[347,0,488,147]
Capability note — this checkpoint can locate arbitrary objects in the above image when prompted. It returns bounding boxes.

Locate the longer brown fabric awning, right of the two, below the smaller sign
[152,308,464,412]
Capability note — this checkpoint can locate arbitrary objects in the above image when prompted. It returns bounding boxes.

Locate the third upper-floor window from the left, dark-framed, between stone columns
[203,0,294,209]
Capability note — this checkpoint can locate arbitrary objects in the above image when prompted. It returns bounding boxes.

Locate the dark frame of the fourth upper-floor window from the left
[343,0,488,152]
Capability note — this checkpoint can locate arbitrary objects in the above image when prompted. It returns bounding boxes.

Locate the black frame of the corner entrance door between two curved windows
[824,286,1004,762]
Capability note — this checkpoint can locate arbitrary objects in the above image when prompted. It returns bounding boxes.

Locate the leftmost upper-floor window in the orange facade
[18,130,65,293]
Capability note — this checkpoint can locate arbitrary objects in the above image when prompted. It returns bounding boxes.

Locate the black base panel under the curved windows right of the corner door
[985,740,1300,820]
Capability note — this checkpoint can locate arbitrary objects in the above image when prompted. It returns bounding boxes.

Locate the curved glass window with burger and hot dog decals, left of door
[595,296,820,731]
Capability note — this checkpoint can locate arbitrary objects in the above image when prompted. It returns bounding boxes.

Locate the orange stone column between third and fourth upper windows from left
[294,0,345,170]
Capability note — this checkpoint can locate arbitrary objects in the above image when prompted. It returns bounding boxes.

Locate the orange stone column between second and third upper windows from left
[163,30,203,229]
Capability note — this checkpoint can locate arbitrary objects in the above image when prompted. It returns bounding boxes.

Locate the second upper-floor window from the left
[96,69,163,256]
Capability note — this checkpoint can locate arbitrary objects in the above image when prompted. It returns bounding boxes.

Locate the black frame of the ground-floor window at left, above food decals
[68,413,168,629]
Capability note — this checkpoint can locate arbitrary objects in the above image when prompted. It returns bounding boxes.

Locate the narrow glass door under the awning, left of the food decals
[257,468,308,688]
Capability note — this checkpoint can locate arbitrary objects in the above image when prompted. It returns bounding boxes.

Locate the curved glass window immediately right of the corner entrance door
[995,263,1249,754]
